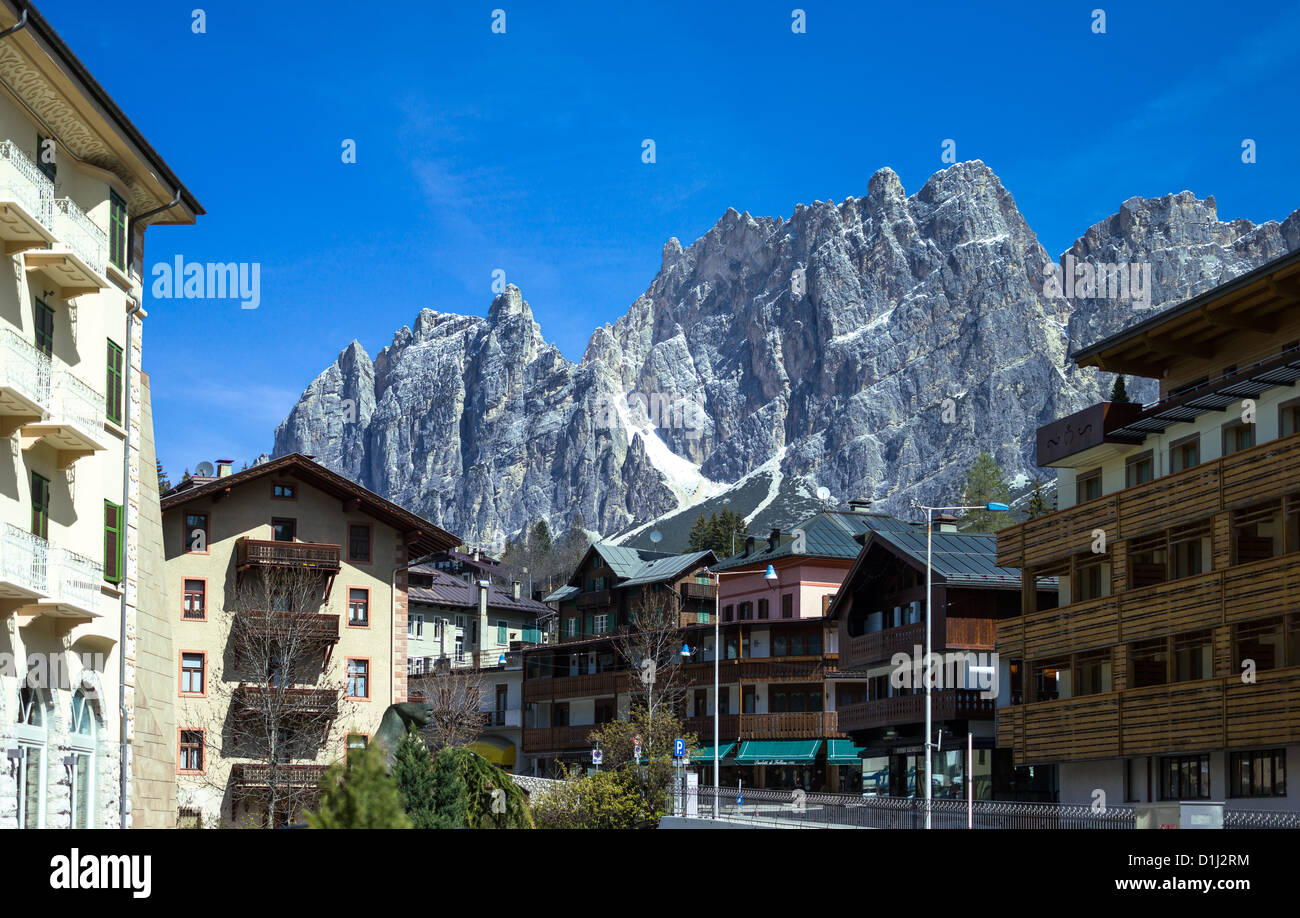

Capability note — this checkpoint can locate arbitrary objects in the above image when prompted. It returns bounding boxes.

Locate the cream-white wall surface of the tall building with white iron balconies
[0,88,142,827]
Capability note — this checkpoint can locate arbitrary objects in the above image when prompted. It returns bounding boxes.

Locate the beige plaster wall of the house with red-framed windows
[163,477,407,822]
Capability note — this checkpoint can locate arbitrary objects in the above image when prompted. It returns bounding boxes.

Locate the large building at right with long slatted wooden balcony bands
[997,254,1300,811]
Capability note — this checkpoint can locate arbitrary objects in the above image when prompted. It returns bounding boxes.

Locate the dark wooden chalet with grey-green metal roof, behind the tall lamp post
[829,518,1057,800]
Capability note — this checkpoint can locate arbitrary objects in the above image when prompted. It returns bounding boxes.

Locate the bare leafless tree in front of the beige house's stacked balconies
[187,567,354,827]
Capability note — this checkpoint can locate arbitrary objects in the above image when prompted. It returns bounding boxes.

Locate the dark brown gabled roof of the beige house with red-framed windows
[161,452,460,557]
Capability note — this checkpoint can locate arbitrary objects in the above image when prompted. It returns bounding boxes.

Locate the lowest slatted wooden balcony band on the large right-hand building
[997,667,1300,765]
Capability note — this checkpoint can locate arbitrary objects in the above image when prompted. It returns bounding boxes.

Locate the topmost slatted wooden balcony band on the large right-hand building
[997,433,1300,567]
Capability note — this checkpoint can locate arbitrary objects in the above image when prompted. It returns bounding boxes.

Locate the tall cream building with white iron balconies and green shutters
[0,0,204,828]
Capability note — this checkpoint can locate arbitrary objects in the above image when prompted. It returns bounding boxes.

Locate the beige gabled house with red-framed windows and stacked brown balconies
[163,454,459,826]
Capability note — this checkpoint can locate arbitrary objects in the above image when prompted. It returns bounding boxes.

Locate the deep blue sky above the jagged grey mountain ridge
[40,0,1300,480]
